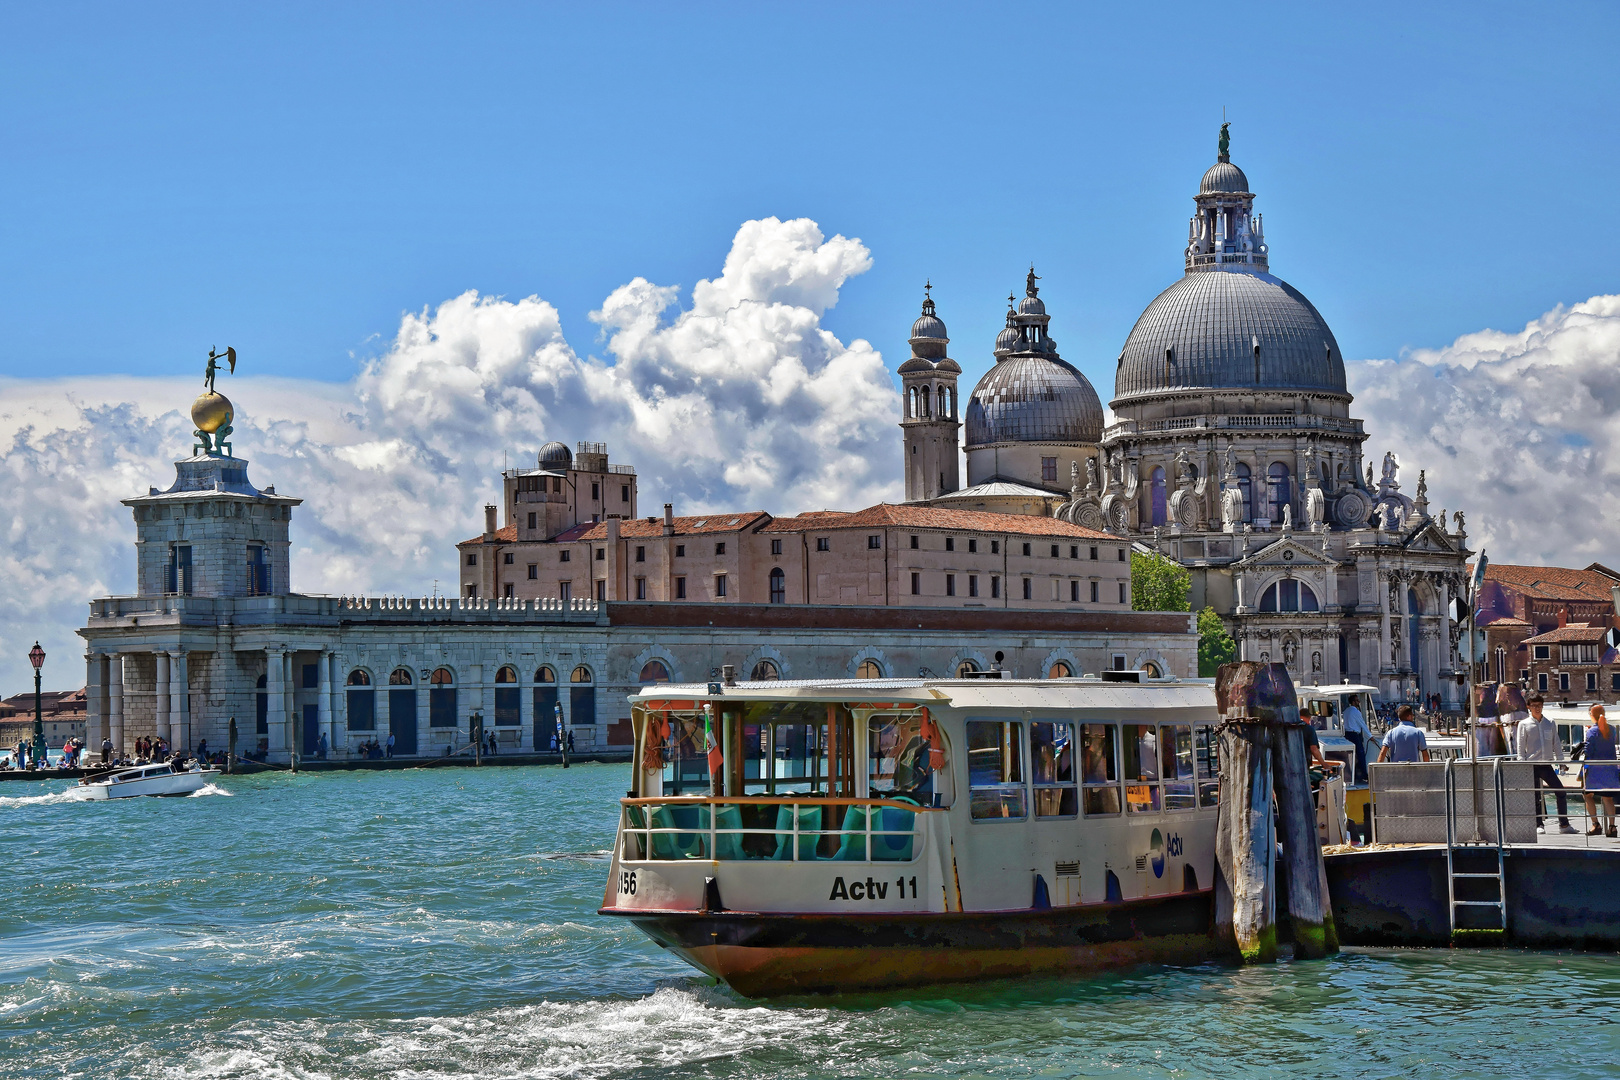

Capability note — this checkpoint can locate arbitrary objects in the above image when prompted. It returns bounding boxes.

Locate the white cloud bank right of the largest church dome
[1349,296,1620,567]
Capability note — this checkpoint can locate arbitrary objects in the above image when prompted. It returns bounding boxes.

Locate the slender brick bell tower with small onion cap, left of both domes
[901,283,962,502]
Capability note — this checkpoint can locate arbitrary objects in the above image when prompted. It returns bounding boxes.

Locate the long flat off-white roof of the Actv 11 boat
[632,678,1215,709]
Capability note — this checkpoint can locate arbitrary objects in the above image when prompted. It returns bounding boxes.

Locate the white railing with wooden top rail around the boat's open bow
[619,795,932,863]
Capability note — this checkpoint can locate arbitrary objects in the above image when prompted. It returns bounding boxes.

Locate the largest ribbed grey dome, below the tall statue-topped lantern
[1115,270,1346,406]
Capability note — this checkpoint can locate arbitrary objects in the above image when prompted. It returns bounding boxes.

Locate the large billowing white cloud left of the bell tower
[0,219,901,691]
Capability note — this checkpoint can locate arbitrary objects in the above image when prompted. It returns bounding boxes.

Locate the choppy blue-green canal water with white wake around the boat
[0,766,1620,1080]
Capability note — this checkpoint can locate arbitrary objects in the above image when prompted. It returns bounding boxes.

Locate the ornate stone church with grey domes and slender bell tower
[899,128,1471,703]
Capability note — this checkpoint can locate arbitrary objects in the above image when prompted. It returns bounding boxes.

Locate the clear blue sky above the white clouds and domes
[0,3,1620,400]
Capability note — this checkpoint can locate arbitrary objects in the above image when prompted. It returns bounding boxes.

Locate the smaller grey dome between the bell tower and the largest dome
[967,355,1103,447]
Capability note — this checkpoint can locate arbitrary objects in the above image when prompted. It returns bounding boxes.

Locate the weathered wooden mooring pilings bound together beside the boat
[1215,661,1338,963]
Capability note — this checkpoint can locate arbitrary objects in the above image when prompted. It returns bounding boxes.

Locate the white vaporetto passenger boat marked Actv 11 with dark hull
[601,672,1218,996]
